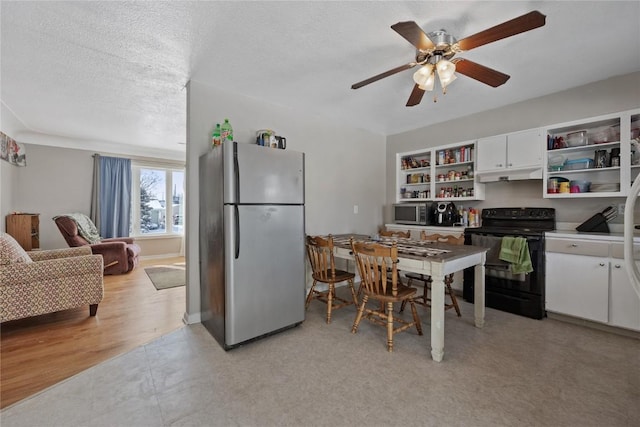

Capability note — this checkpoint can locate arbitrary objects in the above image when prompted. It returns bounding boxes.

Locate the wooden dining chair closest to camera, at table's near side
[351,239,422,351]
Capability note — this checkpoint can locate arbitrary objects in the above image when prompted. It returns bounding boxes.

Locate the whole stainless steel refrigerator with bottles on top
[200,142,305,350]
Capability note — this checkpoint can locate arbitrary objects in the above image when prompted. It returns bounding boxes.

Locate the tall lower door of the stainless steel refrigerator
[224,205,305,346]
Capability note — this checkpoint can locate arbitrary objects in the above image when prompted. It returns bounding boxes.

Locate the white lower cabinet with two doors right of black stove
[546,237,640,331]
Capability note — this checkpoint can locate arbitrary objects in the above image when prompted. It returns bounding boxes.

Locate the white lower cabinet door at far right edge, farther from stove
[609,258,640,331]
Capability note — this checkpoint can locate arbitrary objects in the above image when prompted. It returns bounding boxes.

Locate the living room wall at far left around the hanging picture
[0,101,24,232]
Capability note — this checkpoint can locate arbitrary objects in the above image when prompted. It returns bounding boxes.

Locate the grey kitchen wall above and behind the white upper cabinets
[385,72,640,223]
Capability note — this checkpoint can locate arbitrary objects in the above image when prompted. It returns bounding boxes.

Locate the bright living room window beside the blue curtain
[131,163,184,236]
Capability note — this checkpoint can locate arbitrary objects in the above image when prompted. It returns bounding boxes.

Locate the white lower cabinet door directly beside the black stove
[545,252,609,323]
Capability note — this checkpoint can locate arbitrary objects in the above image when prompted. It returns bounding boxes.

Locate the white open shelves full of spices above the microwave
[396,141,484,202]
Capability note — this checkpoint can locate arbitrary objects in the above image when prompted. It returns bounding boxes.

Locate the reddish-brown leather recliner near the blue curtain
[53,215,140,274]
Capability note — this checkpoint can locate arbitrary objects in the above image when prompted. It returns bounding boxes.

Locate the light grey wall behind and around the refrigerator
[186,81,386,322]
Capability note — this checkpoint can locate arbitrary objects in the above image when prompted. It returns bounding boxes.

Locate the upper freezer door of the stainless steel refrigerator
[224,142,304,204]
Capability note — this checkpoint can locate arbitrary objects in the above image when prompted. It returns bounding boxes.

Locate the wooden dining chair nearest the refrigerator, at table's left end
[305,235,358,323]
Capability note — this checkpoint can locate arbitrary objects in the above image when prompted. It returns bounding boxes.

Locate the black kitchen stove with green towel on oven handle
[463,208,556,319]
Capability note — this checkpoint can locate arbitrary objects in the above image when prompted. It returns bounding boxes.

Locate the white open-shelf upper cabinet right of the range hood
[543,110,640,198]
